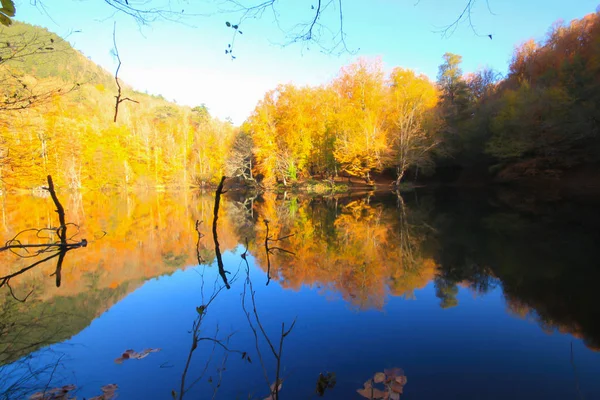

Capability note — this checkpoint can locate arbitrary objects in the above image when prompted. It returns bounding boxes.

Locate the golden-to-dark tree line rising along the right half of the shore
[242,13,600,183]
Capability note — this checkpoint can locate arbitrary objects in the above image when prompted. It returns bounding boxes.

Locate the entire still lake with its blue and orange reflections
[0,191,600,399]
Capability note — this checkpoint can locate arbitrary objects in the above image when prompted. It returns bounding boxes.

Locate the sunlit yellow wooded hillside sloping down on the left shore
[0,23,235,190]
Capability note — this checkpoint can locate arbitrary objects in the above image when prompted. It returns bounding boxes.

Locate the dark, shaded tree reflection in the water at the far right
[435,191,600,349]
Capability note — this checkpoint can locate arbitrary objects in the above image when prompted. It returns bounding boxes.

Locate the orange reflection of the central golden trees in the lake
[247,194,435,307]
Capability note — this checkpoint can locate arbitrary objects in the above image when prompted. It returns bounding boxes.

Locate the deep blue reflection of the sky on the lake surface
[21,251,600,399]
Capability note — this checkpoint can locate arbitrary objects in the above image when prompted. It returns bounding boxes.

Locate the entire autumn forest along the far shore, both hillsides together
[0,13,600,190]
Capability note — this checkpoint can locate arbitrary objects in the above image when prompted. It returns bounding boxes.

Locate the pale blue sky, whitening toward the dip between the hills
[15,0,598,124]
